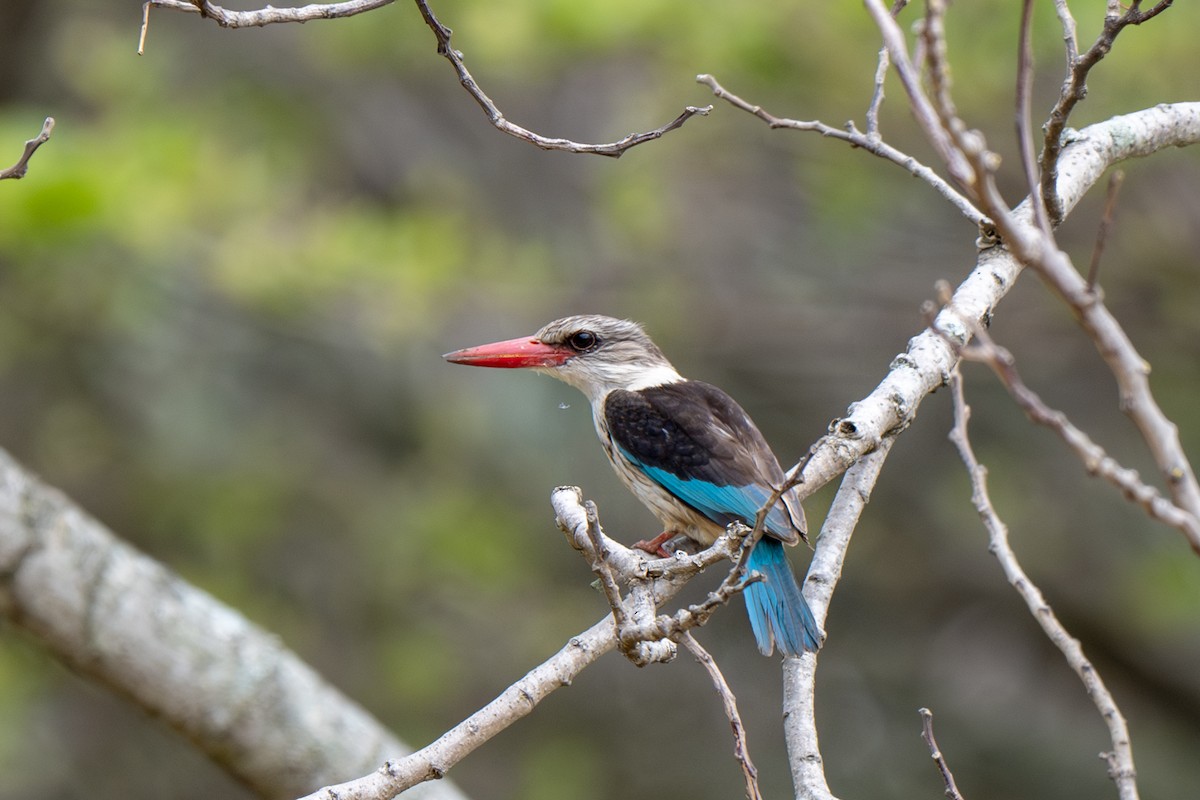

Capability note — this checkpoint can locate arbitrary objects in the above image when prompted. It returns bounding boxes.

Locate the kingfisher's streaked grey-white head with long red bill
[443,314,682,401]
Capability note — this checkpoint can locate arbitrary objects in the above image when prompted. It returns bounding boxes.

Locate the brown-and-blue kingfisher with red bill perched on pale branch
[443,314,822,656]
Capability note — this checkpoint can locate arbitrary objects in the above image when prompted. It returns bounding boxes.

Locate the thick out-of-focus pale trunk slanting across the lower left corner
[0,451,462,800]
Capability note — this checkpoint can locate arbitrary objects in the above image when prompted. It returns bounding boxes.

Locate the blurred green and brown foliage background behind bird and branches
[0,0,1200,800]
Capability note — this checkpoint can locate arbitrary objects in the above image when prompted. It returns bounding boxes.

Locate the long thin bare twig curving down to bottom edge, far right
[950,369,1138,800]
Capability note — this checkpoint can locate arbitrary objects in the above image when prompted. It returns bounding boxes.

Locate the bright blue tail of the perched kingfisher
[744,536,821,656]
